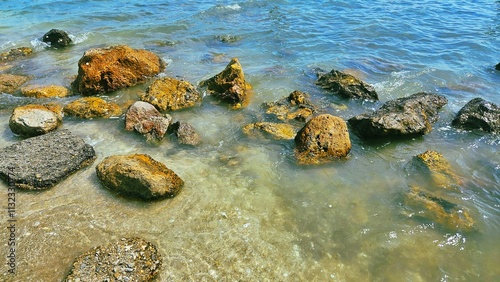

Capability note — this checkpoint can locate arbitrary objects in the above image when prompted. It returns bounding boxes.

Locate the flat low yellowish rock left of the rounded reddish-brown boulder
[243,122,297,140]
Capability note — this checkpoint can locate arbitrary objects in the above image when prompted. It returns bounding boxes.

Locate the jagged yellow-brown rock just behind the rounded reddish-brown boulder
[263,90,316,121]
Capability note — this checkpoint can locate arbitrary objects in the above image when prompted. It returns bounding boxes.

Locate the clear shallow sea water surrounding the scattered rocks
[0,0,500,281]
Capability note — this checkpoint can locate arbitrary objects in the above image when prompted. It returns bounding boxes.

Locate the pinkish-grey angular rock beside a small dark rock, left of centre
[125,101,172,141]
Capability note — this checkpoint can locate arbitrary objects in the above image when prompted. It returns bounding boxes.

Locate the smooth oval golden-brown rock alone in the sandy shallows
[96,154,184,199]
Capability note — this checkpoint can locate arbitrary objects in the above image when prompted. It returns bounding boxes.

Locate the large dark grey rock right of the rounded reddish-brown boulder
[348,93,448,138]
